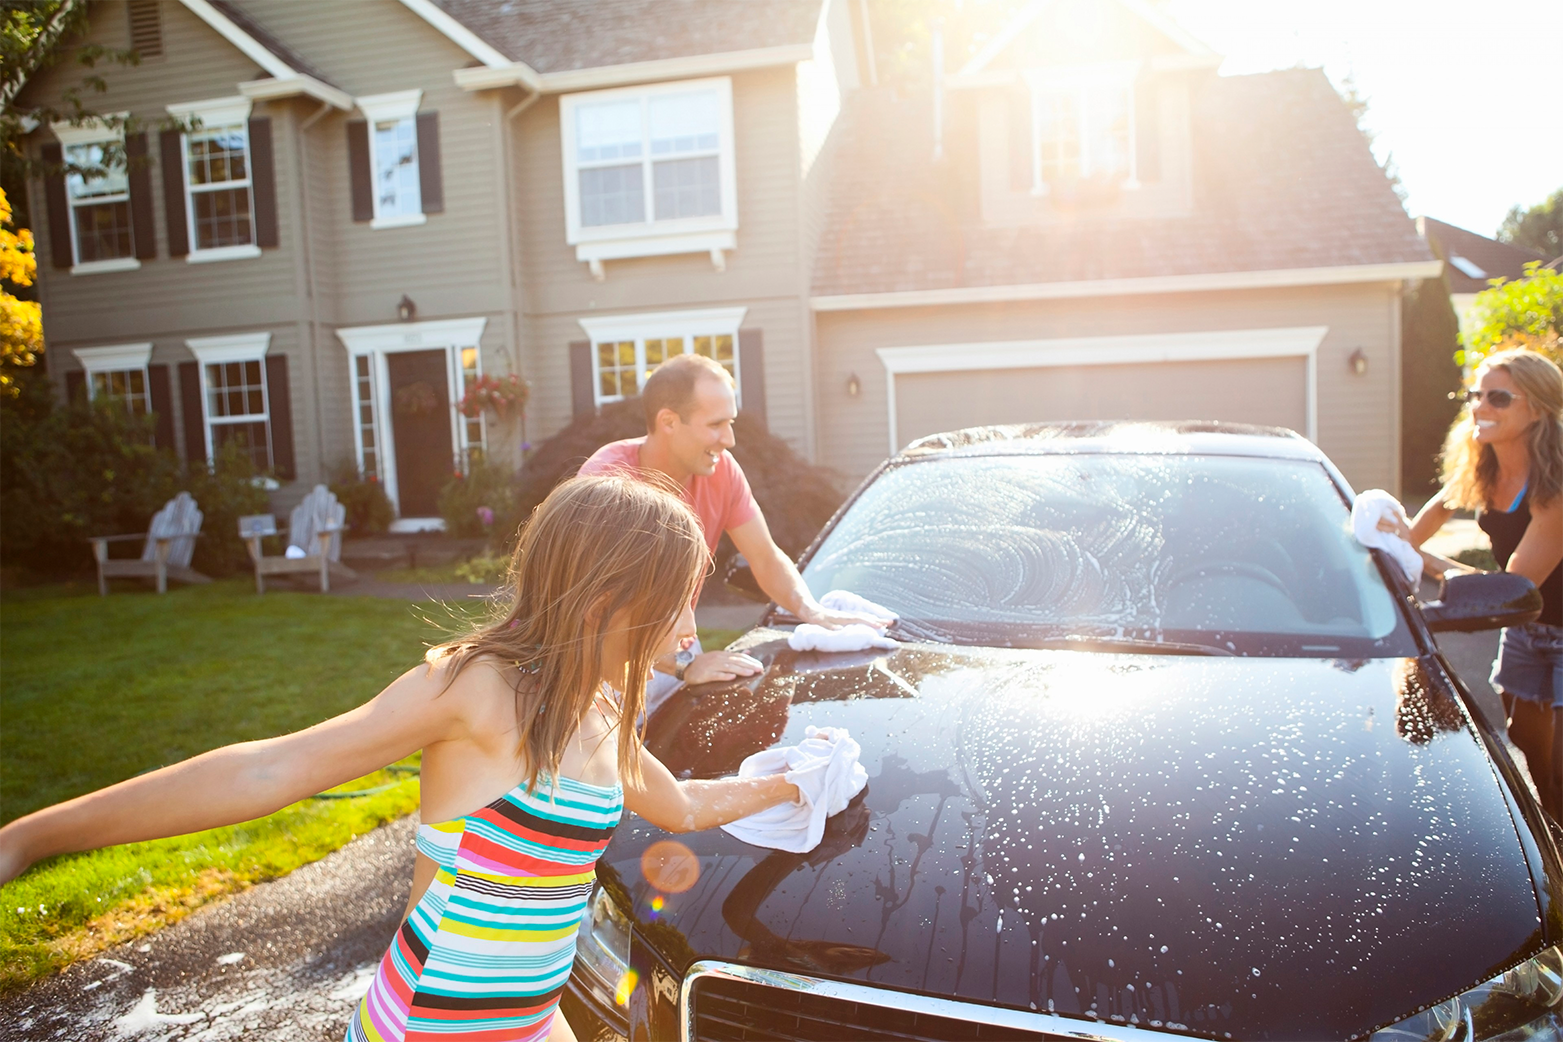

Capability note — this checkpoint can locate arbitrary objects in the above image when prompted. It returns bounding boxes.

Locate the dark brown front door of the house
[386,350,456,517]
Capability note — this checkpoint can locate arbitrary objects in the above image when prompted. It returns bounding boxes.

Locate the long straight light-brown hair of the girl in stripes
[428,475,711,790]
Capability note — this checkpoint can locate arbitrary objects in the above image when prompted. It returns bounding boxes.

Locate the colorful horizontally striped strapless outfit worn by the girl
[347,778,624,1042]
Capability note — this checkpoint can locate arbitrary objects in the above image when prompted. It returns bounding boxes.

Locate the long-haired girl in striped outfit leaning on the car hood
[0,476,797,1042]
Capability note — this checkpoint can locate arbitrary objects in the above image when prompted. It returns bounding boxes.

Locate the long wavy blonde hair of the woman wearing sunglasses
[1443,348,1563,509]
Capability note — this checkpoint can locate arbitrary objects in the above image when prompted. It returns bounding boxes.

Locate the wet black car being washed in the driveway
[564,423,1563,1042]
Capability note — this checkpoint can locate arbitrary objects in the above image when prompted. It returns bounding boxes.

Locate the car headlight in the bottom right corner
[1371,947,1563,1042]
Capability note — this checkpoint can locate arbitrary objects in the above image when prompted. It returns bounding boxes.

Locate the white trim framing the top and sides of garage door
[874,325,1330,456]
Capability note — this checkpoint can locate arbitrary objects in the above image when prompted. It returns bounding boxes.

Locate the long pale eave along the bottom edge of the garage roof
[808,259,1444,311]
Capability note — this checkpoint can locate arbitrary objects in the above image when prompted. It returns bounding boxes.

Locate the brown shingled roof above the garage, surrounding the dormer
[813,69,1438,306]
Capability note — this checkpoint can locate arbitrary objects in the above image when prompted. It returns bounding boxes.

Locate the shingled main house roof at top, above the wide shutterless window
[402,0,824,81]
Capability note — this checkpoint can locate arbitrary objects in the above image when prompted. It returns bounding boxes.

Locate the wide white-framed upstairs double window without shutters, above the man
[560,78,738,272]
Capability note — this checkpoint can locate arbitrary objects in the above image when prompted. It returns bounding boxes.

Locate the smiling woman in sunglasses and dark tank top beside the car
[1396,350,1563,820]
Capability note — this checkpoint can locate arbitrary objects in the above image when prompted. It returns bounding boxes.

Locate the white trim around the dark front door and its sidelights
[336,316,488,522]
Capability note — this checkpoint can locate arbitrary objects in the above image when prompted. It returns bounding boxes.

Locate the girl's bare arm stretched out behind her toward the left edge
[0,666,463,884]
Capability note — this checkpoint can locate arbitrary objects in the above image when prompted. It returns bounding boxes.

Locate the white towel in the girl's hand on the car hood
[722,726,869,855]
